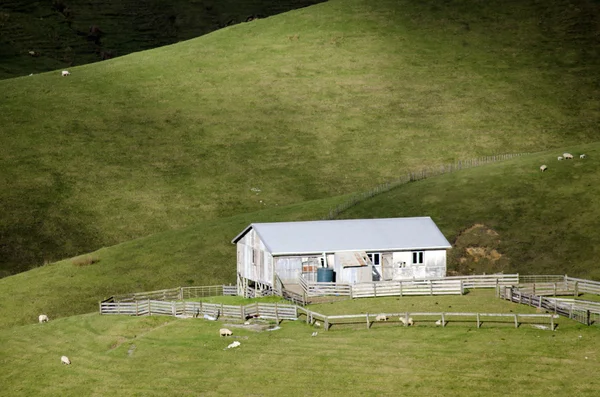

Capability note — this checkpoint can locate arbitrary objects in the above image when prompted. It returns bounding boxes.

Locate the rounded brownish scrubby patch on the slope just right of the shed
[448,223,510,275]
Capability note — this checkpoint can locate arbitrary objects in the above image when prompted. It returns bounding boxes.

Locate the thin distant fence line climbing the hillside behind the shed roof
[325,153,530,219]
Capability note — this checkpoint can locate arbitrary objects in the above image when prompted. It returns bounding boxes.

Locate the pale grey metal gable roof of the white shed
[232,216,451,255]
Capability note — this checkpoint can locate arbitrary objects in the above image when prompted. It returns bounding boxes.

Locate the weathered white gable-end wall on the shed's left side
[237,230,273,286]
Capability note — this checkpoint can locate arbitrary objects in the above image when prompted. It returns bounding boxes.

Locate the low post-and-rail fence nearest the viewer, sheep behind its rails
[298,308,558,331]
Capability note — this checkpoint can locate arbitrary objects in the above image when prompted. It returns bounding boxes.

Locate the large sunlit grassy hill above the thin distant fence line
[0,0,600,274]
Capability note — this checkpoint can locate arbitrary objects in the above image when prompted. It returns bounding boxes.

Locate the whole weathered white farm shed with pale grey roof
[232,217,451,289]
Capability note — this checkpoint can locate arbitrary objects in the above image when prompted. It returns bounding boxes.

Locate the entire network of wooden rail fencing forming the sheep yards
[99,274,600,330]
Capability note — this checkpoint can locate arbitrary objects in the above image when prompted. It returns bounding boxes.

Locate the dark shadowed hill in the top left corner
[0,0,320,78]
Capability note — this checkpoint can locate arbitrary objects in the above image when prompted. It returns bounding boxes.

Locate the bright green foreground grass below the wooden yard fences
[0,295,600,396]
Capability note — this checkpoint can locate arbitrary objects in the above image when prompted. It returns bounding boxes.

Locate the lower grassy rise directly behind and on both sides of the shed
[0,143,600,328]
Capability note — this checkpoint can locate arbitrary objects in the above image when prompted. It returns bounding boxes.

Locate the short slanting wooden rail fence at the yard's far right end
[499,287,600,325]
